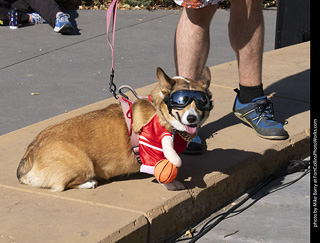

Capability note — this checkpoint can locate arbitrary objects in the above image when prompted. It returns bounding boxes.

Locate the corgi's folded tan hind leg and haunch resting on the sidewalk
[23,141,95,191]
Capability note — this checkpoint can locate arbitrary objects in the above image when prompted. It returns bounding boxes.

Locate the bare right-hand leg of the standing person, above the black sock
[229,0,264,87]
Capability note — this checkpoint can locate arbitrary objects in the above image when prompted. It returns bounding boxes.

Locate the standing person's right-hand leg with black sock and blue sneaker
[229,0,288,139]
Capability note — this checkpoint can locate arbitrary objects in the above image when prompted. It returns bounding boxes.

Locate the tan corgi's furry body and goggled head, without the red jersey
[17,67,213,191]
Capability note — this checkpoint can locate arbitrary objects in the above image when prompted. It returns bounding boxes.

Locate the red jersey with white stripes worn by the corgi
[139,114,187,166]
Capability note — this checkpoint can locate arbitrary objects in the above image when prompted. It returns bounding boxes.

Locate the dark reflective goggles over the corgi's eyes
[164,90,211,111]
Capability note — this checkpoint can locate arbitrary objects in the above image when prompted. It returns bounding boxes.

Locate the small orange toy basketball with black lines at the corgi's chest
[154,159,178,184]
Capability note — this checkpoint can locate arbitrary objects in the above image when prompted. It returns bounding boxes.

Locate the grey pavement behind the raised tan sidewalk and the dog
[0,9,276,135]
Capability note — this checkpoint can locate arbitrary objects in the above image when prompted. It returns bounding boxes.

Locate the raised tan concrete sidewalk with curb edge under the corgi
[0,42,310,242]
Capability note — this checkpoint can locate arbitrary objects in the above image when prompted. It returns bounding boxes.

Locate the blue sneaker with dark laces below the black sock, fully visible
[233,89,289,139]
